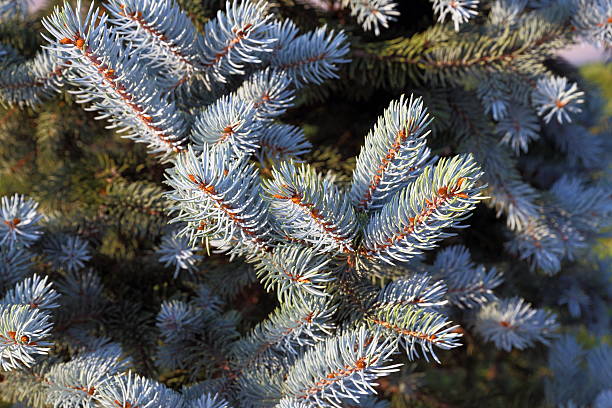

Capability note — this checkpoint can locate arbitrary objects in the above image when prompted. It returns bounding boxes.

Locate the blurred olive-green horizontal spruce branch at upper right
[350,14,571,89]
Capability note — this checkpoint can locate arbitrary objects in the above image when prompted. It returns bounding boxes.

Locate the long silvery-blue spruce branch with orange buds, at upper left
[43,3,186,155]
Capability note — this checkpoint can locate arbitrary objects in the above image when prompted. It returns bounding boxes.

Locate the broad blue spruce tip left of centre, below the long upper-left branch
[166,145,273,251]
